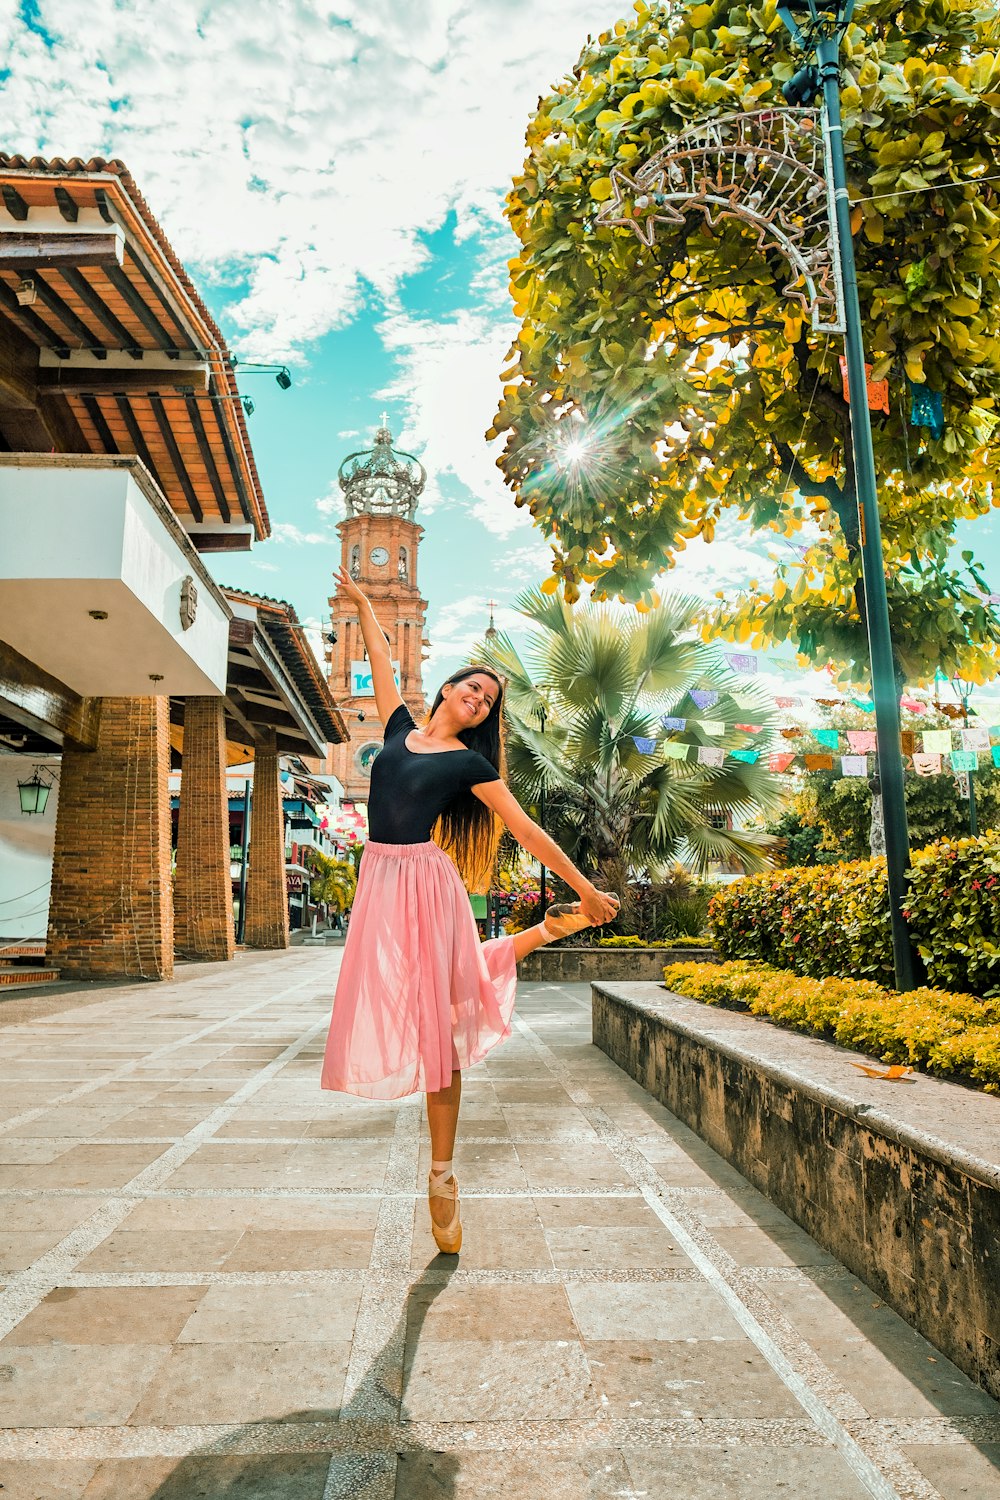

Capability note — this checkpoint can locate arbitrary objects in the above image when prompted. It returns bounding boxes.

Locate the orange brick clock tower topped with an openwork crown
[328,413,427,803]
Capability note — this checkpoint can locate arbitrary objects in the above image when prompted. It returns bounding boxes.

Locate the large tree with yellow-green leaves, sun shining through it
[490,0,1000,683]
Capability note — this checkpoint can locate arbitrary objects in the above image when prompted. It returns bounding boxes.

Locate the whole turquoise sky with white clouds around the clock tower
[0,0,1000,714]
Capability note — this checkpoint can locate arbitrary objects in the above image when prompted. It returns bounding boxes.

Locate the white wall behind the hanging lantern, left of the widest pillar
[0,755,60,945]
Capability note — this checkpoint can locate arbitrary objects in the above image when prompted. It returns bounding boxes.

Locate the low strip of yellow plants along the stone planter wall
[663,962,1000,1094]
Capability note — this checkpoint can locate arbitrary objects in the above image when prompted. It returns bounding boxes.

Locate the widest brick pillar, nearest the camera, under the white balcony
[46,698,174,980]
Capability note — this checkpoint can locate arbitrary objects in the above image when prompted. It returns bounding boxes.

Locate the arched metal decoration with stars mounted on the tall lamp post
[597,110,844,333]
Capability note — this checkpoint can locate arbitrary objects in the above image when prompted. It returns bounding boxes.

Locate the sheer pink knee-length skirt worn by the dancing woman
[322,843,517,1100]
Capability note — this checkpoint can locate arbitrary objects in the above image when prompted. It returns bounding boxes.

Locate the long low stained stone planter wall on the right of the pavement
[592,983,1000,1398]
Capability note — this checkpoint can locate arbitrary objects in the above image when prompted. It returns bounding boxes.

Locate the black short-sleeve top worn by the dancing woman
[369,704,501,843]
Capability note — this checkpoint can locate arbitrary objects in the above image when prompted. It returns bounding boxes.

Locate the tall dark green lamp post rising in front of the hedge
[778,0,915,990]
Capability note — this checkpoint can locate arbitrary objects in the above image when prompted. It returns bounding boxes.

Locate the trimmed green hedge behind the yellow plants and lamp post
[709,833,1000,996]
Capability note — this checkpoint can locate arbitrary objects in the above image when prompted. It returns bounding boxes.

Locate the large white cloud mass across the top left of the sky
[0,0,610,360]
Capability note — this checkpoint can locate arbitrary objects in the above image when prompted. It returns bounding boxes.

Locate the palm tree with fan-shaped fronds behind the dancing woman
[480,588,783,930]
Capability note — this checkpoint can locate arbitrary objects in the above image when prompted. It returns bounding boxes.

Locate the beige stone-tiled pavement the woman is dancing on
[0,948,1000,1500]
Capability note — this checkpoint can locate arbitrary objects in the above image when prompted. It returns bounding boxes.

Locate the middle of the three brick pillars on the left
[174,698,235,962]
